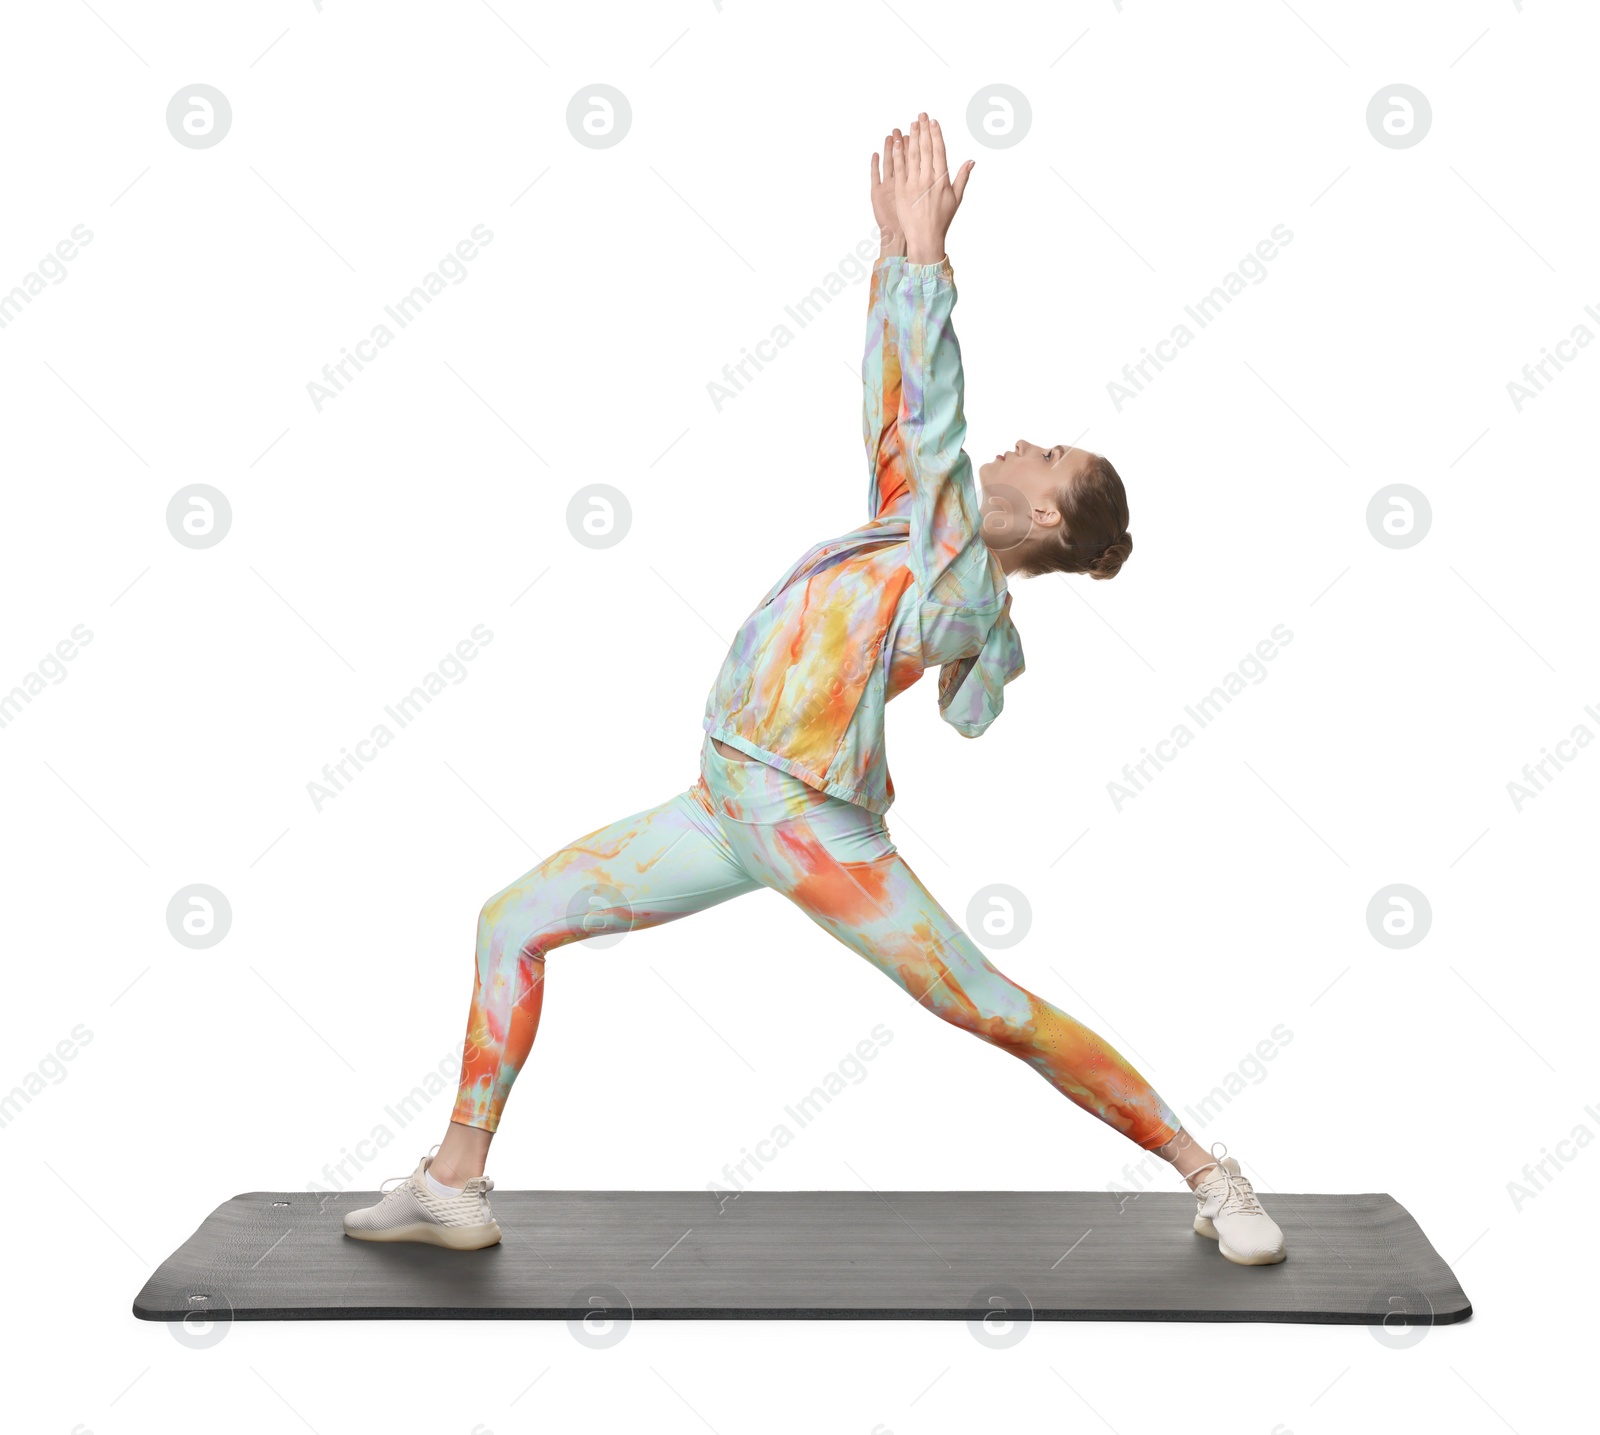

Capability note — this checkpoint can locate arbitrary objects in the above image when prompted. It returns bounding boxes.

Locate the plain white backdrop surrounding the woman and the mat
[0,0,1600,1435]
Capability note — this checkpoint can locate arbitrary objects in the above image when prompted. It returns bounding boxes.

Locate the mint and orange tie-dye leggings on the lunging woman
[451,739,1178,1150]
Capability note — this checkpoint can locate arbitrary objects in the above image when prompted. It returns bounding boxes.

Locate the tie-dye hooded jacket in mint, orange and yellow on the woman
[704,256,1022,813]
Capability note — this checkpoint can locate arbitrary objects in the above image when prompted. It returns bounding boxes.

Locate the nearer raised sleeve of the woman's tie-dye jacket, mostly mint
[880,259,1000,608]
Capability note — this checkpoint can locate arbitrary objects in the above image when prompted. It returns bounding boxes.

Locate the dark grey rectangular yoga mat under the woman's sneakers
[133,1190,1472,1326]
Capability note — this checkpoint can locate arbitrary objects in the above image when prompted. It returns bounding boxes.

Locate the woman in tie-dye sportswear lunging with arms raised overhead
[344,114,1283,1265]
